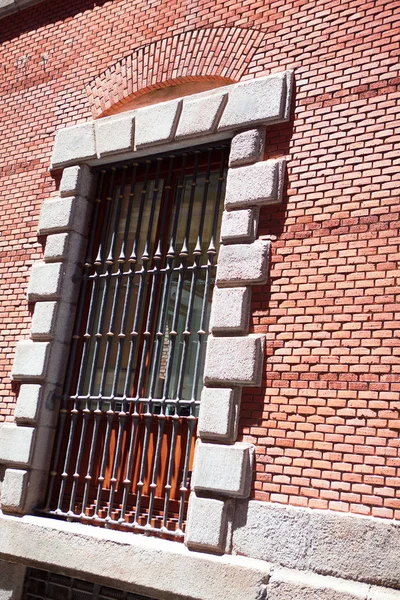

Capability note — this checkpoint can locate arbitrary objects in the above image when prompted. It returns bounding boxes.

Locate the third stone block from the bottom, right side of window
[197,387,242,443]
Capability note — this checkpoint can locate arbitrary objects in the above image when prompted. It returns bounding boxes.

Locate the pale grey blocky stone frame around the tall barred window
[0,71,293,554]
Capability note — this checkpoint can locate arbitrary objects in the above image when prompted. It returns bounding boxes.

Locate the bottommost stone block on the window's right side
[185,494,232,554]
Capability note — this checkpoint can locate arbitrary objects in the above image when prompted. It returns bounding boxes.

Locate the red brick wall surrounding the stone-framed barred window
[0,0,400,518]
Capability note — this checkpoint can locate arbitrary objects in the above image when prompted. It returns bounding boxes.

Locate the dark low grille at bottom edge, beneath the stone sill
[22,568,154,600]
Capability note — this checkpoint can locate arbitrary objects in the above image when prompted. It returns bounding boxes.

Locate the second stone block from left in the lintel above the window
[95,113,135,157]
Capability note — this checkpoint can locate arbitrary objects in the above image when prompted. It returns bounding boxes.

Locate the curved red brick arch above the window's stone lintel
[86,27,265,118]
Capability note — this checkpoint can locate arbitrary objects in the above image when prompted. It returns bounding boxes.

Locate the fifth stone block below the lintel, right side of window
[210,287,251,334]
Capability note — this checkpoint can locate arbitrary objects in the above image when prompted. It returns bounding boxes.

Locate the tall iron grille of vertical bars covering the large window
[45,144,227,538]
